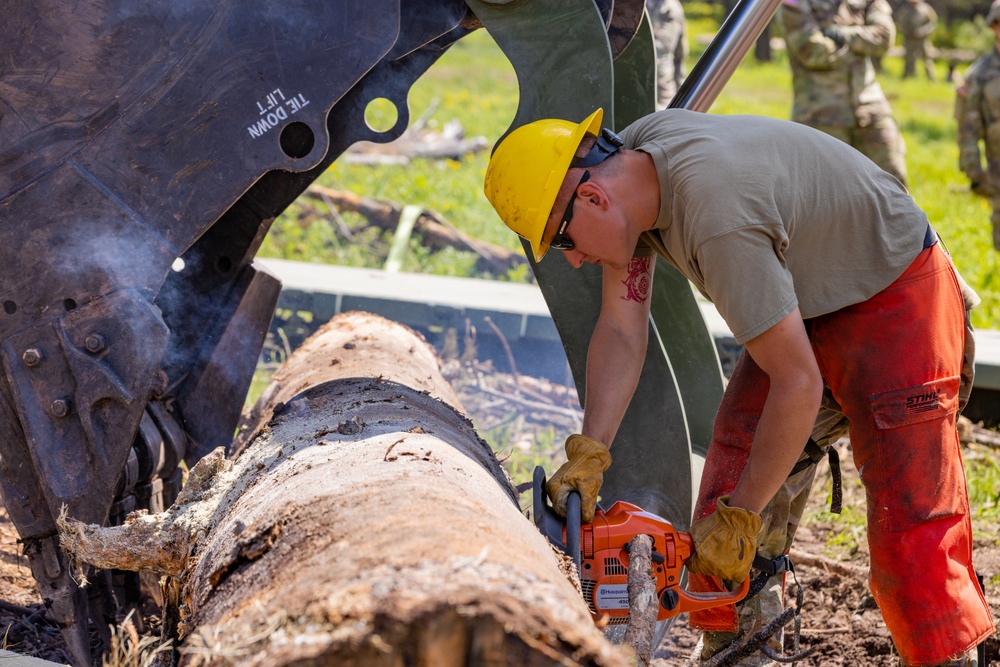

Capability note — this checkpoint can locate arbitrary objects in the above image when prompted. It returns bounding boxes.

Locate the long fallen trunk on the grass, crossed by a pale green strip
[305,184,527,273]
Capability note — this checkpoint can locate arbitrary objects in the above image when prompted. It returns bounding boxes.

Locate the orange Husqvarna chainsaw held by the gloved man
[532,466,750,625]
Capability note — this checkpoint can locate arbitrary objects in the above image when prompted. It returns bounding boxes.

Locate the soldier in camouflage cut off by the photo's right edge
[955,0,1000,250]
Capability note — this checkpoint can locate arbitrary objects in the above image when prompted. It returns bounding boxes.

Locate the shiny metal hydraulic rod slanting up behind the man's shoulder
[668,0,781,111]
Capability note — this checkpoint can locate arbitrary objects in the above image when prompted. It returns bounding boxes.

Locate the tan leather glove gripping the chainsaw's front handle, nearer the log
[545,434,611,523]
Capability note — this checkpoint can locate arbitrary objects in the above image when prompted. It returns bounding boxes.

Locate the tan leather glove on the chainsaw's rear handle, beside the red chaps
[687,496,763,581]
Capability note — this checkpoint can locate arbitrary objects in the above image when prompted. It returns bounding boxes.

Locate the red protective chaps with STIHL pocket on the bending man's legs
[689,246,994,666]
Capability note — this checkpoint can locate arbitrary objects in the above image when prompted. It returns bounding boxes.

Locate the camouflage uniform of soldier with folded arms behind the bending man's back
[781,0,906,185]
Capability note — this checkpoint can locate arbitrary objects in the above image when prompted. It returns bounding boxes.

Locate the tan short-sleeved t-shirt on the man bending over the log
[622,109,928,343]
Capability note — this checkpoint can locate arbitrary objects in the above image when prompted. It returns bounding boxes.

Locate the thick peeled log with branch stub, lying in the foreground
[60,313,628,667]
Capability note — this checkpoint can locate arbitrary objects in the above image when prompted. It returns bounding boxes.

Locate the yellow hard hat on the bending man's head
[484,109,604,262]
